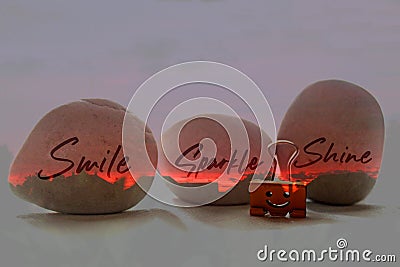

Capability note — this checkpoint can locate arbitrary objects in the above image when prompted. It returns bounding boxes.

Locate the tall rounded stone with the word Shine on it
[277,80,385,205]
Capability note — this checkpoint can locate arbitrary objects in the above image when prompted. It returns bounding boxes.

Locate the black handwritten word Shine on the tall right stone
[294,137,372,168]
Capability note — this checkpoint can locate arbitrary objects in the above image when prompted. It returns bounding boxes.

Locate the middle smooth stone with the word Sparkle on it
[158,114,272,205]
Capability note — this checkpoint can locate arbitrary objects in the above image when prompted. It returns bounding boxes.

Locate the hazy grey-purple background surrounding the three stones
[0,0,400,266]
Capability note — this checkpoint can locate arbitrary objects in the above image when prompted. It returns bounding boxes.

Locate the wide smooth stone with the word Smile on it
[9,99,157,214]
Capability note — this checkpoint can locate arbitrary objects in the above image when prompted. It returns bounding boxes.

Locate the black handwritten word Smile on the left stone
[38,136,130,180]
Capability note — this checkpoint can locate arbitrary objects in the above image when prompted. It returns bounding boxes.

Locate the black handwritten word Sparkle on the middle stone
[175,143,264,177]
